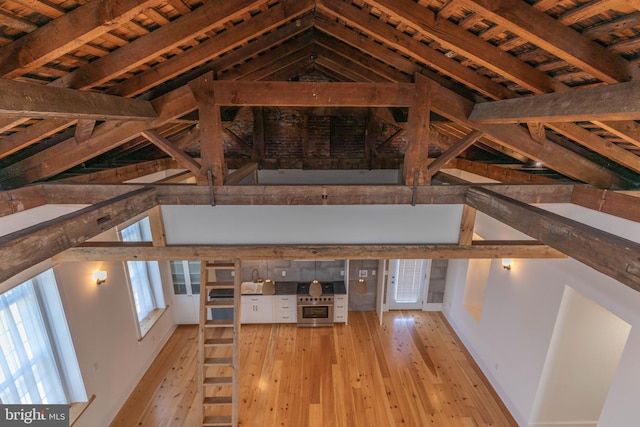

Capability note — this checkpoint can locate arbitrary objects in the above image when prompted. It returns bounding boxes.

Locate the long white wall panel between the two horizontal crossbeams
[162,205,462,244]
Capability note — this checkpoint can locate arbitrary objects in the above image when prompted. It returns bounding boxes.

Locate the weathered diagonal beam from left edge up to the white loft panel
[0,188,157,282]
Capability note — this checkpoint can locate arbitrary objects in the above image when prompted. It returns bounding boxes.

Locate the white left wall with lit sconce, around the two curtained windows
[0,214,175,427]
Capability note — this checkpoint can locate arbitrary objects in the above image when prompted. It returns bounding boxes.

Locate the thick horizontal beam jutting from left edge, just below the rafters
[0,79,158,121]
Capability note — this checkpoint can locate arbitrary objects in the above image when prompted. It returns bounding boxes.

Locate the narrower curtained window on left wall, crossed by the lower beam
[120,217,165,338]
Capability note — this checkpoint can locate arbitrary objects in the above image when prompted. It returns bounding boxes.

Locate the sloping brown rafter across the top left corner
[0,0,162,79]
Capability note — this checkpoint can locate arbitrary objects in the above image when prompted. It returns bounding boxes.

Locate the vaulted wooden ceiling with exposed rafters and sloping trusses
[0,0,640,189]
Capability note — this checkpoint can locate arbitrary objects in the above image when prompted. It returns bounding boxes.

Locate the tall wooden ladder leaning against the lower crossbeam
[199,261,242,427]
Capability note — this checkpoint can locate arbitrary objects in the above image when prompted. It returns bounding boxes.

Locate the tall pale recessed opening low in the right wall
[530,286,631,427]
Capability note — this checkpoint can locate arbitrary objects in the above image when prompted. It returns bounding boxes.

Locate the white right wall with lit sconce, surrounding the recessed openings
[443,205,640,427]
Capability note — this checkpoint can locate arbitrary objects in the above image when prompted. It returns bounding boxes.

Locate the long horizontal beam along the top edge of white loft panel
[31,183,576,206]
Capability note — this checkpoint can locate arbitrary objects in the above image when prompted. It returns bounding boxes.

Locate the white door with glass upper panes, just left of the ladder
[169,261,200,325]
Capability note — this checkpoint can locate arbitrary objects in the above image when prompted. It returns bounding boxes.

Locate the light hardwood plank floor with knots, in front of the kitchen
[111,311,517,427]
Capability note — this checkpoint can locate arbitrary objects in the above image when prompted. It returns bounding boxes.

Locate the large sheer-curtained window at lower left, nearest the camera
[0,270,87,404]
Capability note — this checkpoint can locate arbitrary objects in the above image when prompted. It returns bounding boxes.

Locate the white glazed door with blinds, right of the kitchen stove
[387,259,429,310]
